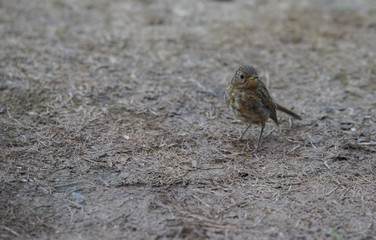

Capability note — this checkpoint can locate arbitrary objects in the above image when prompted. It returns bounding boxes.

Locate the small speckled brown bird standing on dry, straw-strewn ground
[224,66,302,153]
